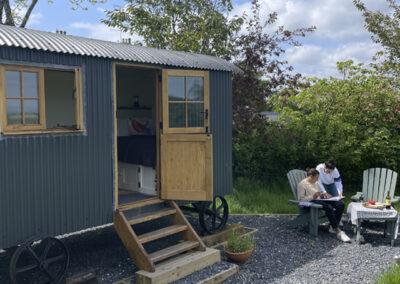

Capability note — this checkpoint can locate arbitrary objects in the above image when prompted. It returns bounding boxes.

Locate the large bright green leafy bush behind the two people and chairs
[272,61,400,178]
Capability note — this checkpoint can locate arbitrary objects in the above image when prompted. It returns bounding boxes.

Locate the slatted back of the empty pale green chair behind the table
[362,168,397,203]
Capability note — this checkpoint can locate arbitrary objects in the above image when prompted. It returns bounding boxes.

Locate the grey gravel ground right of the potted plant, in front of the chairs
[226,216,400,283]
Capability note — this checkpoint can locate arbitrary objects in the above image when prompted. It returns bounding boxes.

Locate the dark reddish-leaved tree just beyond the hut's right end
[233,0,315,137]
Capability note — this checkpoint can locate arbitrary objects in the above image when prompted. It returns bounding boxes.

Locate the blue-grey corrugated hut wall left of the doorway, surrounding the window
[0,47,114,248]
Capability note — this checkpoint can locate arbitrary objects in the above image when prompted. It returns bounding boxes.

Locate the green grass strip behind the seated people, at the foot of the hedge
[225,178,400,214]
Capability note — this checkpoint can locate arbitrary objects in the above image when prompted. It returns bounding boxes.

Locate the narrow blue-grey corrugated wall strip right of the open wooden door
[210,71,232,196]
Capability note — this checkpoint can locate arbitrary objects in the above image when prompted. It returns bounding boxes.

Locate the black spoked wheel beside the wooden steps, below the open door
[199,195,229,234]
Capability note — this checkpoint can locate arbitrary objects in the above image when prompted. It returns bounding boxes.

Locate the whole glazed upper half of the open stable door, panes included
[163,70,209,133]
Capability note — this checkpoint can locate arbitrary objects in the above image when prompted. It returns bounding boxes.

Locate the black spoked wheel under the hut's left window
[10,237,69,284]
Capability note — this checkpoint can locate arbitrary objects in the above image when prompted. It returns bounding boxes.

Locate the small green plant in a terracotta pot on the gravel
[224,232,256,262]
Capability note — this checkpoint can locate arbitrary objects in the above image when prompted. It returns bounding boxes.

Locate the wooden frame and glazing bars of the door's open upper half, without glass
[162,69,210,133]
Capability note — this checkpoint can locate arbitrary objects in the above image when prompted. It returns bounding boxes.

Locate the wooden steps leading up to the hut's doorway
[114,198,206,272]
